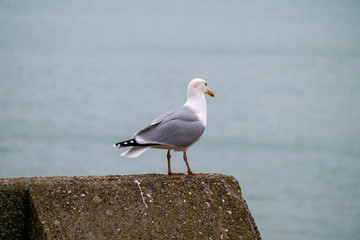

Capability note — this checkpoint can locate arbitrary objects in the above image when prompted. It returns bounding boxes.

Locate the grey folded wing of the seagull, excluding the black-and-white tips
[135,107,205,148]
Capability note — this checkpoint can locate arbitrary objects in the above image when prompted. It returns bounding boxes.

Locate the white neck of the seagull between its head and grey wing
[184,92,207,127]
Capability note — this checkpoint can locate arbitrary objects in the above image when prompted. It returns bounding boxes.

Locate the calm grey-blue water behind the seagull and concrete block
[0,0,360,240]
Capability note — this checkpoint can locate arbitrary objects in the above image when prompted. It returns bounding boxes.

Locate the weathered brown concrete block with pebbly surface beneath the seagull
[0,174,261,240]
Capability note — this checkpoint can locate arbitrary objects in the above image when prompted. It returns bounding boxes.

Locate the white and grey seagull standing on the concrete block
[113,78,215,175]
